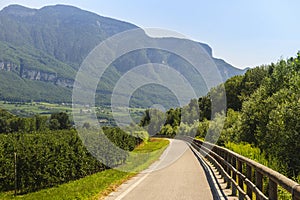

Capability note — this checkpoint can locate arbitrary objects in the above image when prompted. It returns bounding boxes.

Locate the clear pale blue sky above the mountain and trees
[0,0,300,68]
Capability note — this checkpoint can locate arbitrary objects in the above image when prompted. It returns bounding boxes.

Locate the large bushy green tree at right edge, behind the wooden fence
[261,80,300,177]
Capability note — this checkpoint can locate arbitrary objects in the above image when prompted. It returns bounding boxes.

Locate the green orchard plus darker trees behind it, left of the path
[0,110,142,193]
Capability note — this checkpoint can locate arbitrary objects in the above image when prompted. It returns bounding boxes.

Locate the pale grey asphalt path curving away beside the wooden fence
[106,140,213,200]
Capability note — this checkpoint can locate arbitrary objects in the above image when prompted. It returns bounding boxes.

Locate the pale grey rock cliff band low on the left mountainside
[0,61,74,88]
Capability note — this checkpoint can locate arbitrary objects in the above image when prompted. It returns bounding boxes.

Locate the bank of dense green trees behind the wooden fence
[150,53,300,180]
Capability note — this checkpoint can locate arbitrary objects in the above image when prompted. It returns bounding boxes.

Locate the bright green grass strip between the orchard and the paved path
[0,138,169,200]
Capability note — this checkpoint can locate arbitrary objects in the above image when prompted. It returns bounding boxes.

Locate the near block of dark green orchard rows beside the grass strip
[0,130,105,193]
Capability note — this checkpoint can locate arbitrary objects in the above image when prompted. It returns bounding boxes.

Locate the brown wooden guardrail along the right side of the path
[185,138,300,200]
